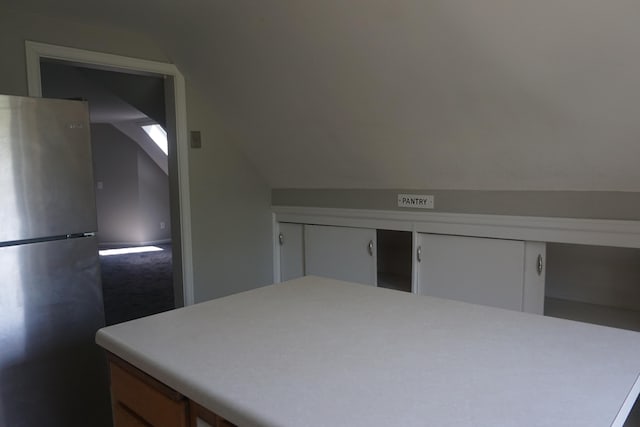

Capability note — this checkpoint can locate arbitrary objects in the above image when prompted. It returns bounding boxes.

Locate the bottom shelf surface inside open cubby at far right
[544,297,640,332]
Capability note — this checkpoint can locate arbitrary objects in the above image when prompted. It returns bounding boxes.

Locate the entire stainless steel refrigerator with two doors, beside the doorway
[0,95,111,427]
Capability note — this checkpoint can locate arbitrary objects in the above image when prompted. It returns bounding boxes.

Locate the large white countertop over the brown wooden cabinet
[96,277,640,427]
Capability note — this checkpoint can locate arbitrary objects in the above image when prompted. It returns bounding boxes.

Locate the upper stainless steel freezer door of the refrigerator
[0,95,97,244]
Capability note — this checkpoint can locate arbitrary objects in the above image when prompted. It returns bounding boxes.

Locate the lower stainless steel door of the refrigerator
[0,237,111,427]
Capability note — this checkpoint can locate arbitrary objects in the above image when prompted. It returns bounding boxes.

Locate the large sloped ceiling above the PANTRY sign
[10,0,640,191]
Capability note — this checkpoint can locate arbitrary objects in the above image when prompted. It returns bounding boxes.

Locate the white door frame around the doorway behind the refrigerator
[25,41,194,305]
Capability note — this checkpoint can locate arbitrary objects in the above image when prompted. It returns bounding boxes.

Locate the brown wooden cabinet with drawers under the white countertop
[109,355,234,427]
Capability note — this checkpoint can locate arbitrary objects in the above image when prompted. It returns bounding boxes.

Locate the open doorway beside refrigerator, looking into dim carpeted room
[40,59,181,326]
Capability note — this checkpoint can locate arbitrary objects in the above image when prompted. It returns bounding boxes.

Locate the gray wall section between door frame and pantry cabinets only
[187,86,273,301]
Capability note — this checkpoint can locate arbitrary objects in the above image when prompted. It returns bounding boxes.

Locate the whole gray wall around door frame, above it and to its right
[0,10,273,301]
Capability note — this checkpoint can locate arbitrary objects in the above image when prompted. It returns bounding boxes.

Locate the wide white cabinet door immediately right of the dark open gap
[418,234,524,311]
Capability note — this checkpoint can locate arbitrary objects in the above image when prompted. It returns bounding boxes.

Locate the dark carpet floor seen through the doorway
[100,245,175,325]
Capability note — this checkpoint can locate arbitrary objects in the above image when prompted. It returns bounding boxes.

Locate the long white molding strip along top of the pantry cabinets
[272,206,640,248]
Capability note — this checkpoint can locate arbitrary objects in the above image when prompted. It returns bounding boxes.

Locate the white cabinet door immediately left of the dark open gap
[304,225,376,286]
